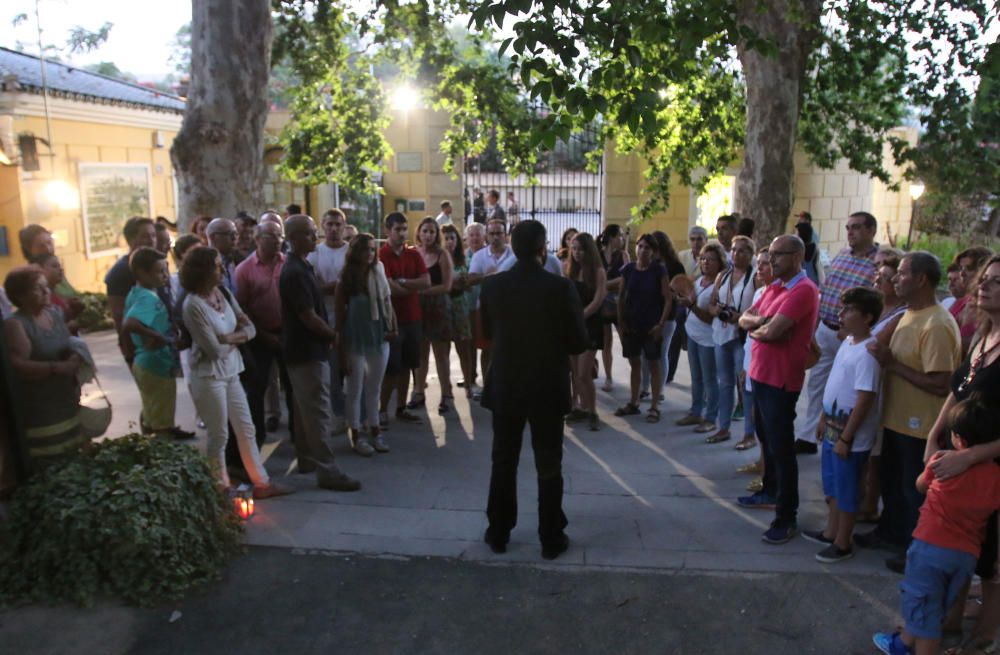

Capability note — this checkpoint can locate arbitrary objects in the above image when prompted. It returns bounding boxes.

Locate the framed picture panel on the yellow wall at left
[80,164,153,257]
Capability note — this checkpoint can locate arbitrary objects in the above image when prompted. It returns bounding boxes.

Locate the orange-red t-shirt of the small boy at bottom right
[913,461,1000,557]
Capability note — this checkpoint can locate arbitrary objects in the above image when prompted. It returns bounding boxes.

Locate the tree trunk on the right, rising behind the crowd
[736,0,822,244]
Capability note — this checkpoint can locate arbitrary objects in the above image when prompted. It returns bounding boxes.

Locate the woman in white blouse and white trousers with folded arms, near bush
[180,247,293,498]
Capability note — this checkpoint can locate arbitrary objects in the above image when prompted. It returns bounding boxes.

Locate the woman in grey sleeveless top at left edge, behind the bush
[3,266,87,465]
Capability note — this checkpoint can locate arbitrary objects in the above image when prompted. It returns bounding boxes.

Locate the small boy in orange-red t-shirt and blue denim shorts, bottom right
[872,395,1000,655]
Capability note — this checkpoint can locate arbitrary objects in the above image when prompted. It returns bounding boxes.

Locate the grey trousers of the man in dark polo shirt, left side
[287,359,336,471]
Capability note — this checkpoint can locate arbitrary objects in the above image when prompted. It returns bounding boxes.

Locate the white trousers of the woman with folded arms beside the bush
[190,375,270,487]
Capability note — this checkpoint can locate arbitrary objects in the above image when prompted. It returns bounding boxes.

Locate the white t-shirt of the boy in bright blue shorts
[823,337,882,453]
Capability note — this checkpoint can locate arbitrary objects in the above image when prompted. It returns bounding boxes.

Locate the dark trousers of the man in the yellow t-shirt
[878,429,927,548]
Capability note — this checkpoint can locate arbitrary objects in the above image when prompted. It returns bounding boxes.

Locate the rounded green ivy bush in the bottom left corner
[0,434,242,605]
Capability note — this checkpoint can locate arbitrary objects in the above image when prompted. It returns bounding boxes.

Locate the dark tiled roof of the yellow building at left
[0,48,184,114]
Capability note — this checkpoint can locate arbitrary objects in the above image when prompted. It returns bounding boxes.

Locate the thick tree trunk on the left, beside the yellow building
[170,0,273,228]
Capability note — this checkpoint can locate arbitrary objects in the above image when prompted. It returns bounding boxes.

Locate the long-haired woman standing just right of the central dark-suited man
[569,232,607,430]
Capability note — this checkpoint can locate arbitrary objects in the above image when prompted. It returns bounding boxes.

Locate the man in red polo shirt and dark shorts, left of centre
[378,212,431,428]
